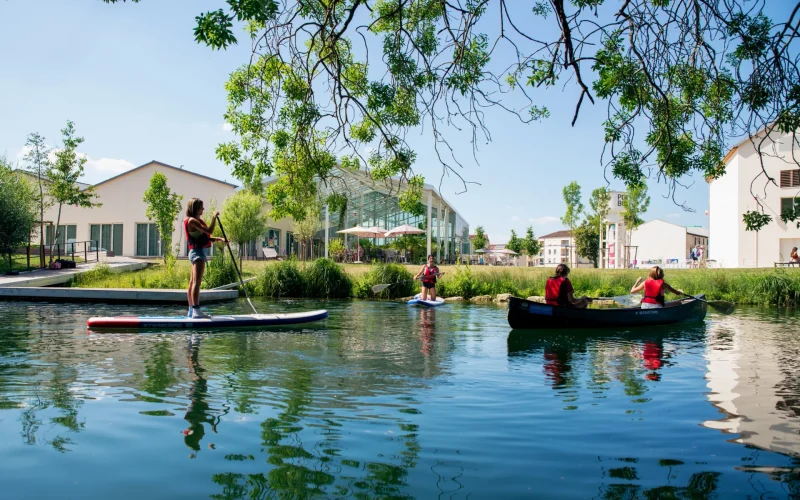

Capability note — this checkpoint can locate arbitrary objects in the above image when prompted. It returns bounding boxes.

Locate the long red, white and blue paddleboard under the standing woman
[86,309,328,330]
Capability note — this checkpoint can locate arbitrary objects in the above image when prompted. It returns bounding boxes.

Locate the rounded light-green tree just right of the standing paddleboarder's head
[220,189,267,269]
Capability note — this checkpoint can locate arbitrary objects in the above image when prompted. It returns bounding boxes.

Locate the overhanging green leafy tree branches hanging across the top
[103,0,800,218]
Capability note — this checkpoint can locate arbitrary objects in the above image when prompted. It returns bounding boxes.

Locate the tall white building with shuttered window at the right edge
[708,131,800,267]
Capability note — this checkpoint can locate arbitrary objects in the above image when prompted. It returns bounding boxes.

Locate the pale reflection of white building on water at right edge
[703,318,800,455]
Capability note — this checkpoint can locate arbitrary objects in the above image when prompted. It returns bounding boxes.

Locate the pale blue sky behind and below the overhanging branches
[0,0,788,243]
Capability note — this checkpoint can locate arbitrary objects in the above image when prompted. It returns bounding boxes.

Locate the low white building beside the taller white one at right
[631,219,710,267]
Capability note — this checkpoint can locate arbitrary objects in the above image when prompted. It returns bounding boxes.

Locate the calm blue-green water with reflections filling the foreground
[0,301,800,499]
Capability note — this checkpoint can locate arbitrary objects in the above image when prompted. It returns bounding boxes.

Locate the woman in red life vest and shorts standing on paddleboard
[183,198,227,318]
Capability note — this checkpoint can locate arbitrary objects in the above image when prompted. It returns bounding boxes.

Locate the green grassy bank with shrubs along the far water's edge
[73,259,800,306]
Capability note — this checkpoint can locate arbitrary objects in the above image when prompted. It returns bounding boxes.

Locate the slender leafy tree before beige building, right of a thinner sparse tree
[47,120,102,263]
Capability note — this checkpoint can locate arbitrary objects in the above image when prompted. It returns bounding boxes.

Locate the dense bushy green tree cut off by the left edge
[0,157,37,271]
